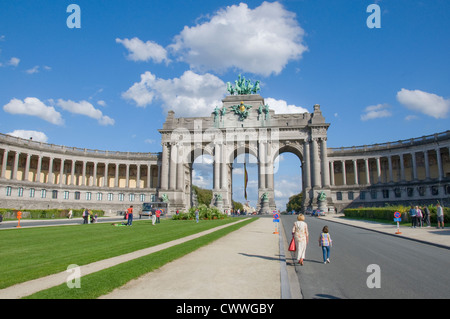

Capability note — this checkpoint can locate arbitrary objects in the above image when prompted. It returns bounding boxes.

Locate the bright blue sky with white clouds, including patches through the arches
[0,0,450,209]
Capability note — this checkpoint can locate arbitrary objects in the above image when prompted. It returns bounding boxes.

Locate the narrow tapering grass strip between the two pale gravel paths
[25,218,256,299]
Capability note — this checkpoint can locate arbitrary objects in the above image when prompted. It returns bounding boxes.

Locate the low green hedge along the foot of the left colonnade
[0,208,105,219]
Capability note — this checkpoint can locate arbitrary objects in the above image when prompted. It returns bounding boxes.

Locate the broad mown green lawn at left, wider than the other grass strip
[0,218,243,289]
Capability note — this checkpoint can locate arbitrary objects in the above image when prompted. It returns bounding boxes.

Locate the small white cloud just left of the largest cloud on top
[116,38,170,63]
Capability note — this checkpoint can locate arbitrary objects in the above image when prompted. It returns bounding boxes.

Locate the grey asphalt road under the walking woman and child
[282,216,450,299]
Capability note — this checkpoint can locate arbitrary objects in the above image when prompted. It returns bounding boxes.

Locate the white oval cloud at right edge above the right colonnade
[397,89,450,119]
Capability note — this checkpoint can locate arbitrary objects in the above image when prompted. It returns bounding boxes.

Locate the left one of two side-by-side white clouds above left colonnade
[3,97,64,125]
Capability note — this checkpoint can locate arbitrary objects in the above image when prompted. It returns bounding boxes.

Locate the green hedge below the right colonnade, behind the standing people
[344,205,450,223]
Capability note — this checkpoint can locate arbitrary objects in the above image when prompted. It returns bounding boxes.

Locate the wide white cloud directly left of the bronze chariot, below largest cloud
[122,71,226,116]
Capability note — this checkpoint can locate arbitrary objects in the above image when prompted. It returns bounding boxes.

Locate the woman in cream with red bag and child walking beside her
[292,214,332,266]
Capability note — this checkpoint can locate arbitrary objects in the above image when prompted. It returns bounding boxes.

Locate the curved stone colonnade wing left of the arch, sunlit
[0,134,160,212]
